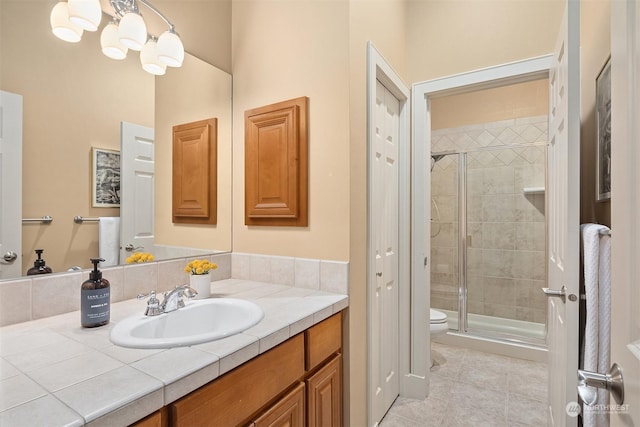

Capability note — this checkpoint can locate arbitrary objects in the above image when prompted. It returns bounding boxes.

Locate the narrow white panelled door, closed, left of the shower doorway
[370,81,400,422]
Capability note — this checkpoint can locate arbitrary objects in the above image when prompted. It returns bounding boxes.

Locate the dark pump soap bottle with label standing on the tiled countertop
[80,258,111,328]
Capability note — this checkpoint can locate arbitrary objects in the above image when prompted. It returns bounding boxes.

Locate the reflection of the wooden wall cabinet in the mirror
[172,118,218,225]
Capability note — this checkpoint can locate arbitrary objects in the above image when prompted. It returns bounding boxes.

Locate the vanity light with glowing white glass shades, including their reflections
[51,0,184,75]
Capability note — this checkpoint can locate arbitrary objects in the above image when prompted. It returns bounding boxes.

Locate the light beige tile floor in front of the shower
[380,343,547,427]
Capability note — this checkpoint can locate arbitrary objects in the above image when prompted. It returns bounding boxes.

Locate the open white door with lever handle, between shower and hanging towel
[547,0,580,426]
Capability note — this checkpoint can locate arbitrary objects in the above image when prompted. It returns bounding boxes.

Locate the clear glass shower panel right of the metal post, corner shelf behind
[466,149,547,340]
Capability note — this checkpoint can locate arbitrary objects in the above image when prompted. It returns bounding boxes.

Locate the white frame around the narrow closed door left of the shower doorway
[367,42,422,424]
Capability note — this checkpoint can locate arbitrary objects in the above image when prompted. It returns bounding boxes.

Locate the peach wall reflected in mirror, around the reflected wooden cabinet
[155,54,232,251]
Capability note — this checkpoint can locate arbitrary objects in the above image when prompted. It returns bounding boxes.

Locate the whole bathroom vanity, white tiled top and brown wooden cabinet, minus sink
[0,279,348,427]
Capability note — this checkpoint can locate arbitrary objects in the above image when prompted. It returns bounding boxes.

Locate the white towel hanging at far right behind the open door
[581,224,611,427]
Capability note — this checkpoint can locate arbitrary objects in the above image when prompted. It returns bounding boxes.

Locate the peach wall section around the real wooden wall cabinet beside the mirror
[232,0,349,261]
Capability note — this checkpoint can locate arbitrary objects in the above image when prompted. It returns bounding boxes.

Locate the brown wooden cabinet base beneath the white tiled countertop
[134,312,342,427]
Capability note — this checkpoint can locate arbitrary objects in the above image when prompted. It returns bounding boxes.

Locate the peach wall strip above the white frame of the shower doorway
[407,0,563,83]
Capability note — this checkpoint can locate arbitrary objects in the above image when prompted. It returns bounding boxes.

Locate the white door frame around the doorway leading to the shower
[411,54,553,392]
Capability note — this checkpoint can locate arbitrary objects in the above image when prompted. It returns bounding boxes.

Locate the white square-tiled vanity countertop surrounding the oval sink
[0,279,348,427]
